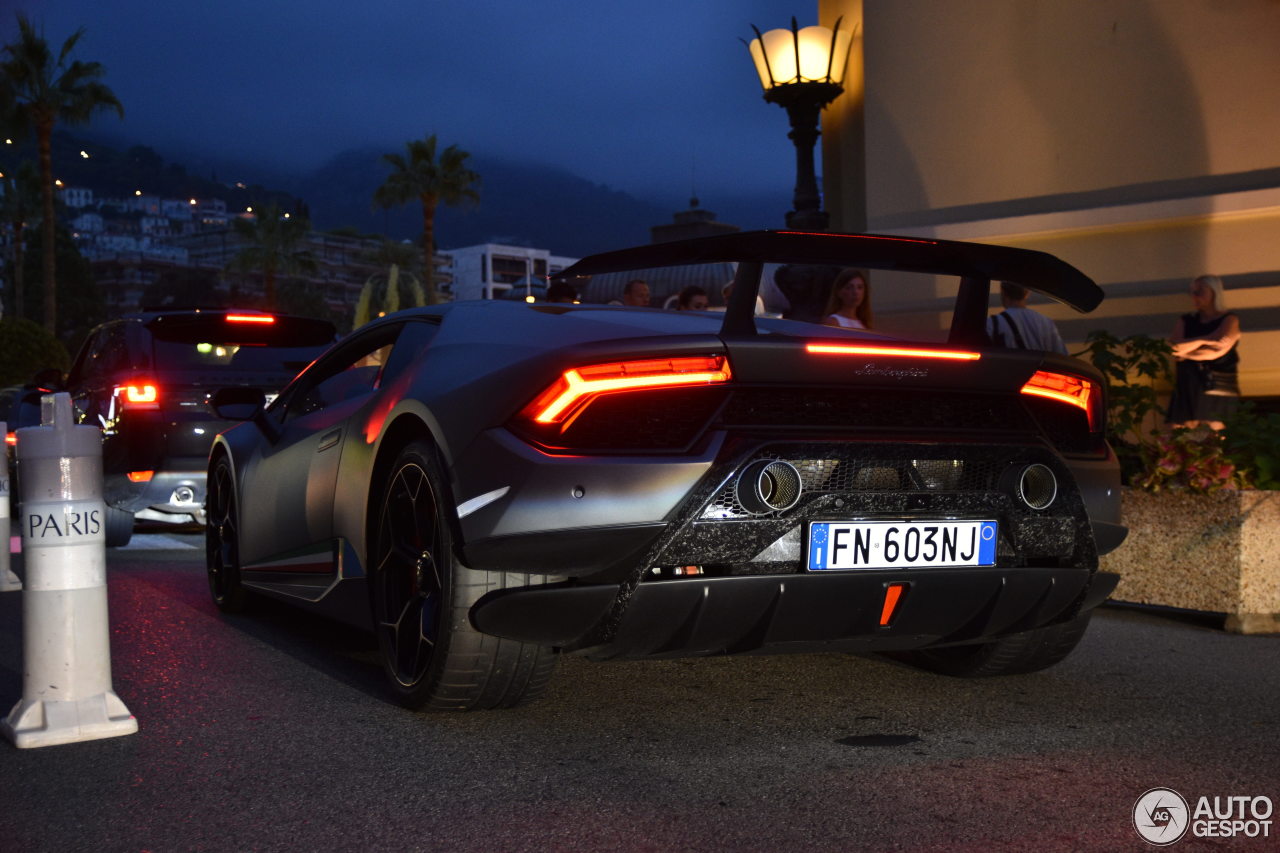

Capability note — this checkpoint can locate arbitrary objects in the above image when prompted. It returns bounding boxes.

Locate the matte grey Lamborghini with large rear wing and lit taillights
[207,232,1125,710]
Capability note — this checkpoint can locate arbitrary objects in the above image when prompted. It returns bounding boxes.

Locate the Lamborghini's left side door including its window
[239,323,403,573]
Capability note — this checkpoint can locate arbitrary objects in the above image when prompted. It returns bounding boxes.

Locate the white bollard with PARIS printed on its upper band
[0,393,138,748]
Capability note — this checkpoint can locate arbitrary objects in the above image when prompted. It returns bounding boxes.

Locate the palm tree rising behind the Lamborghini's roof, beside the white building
[374,133,480,305]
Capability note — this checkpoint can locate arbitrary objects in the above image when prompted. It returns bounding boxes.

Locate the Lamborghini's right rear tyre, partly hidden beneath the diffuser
[900,611,1093,679]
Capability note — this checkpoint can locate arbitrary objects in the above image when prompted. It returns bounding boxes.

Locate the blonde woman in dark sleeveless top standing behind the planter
[1166,275,1240,429]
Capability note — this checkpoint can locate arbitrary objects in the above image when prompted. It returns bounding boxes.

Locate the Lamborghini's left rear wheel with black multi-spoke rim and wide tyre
[369,442,557,711]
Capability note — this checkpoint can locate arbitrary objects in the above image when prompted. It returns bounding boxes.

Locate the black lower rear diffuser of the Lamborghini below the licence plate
[471,569,1119,660]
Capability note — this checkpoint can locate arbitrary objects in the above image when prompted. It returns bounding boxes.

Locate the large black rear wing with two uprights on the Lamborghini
[562,231,1102,343]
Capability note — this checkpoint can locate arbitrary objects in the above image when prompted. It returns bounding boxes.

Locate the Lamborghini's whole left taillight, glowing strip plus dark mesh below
[513,355,732,451]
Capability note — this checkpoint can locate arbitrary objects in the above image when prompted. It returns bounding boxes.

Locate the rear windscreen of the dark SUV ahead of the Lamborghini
[147,314,337,374]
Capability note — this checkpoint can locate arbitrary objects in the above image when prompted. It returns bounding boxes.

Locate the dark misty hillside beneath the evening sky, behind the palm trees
[42,133,790,256]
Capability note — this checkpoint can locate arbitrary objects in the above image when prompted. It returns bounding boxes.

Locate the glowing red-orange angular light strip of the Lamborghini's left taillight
[526,356,731,424]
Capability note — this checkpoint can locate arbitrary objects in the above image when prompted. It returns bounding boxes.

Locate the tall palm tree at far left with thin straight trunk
[0,13,124,333]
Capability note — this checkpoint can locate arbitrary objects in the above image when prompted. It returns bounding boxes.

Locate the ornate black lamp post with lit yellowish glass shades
[748,18,852,231]
